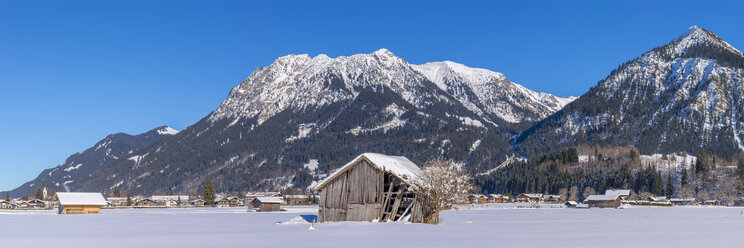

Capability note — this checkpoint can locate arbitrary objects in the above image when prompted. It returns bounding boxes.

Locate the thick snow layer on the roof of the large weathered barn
[315,153,421,191]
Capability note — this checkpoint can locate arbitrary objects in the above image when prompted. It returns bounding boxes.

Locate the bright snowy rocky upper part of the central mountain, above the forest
[210,49,573,128]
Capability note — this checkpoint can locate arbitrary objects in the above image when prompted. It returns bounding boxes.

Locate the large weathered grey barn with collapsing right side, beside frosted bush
[315,153,429,223]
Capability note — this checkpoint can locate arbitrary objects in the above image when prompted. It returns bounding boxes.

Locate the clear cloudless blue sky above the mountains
[0,0,744,190]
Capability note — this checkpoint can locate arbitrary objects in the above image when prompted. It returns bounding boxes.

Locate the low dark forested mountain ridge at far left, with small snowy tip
[10,126,178,197]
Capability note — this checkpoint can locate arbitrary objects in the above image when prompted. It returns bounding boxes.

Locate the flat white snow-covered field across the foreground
[0,204,744,248]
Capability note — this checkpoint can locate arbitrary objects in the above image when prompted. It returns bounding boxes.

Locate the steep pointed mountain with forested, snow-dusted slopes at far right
[514,26,744,157]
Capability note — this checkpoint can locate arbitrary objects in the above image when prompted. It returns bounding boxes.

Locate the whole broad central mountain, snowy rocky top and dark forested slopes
[64,49,570,193]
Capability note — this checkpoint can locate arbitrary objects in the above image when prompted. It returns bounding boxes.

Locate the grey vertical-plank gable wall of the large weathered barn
[318,160,384,222]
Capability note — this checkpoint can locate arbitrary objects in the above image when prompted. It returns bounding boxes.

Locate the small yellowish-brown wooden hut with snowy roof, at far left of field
[54,192,108,214]
